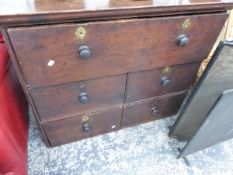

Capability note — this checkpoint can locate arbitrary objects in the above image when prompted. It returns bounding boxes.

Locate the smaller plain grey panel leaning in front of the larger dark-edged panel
[179,90,233,157]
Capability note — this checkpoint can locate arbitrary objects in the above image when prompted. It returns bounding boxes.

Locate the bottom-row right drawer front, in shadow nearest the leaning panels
[123,93,186,127]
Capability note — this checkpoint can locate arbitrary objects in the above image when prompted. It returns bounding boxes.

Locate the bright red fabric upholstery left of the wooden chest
[0,36,28,175]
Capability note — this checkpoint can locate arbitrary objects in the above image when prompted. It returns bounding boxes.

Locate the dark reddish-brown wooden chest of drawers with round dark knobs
[0,0,233,146]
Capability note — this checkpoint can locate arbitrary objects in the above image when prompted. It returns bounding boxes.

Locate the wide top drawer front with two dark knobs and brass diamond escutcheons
[8,13,227,87]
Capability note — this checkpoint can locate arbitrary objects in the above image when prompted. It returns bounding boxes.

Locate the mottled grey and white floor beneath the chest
[28,111,233,175]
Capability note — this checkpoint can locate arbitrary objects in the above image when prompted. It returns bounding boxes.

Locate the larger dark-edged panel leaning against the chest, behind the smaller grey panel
[170,43,233,139]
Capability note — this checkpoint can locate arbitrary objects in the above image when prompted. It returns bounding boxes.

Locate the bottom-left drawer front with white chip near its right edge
[43,108,122,146]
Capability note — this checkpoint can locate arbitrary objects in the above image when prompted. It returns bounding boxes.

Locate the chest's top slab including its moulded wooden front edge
[0,0,233,25]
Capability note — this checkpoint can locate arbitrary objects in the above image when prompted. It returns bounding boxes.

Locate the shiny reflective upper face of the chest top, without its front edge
[0,0,233,15]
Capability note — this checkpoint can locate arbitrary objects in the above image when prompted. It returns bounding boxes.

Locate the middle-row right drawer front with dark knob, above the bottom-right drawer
[126,63,200,103]
